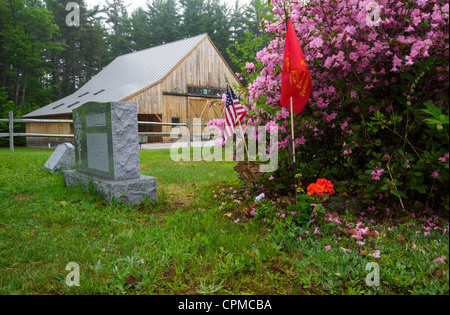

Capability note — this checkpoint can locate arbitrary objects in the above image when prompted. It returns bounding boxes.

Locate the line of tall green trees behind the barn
[0,0,270,118]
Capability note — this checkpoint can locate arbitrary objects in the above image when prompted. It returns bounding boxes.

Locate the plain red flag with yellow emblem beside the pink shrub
[281,19,312,114]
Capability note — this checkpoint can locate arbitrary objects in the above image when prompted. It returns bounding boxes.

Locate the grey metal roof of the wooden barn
[23,34,208,118]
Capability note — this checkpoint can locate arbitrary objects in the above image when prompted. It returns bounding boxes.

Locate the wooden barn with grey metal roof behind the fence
[23,34,240,147]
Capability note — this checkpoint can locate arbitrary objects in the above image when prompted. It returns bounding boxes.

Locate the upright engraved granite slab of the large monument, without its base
[73,103,140,180]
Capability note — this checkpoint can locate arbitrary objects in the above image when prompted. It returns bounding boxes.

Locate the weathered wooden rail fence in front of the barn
[0,111,207,152]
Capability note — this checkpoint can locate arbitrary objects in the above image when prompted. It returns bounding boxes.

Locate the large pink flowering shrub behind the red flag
[230,0,449,212]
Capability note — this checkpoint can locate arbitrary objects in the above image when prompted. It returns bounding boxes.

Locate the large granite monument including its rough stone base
[64,102,158,204]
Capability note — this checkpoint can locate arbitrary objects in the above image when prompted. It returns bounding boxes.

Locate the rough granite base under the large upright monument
[63,170,158,205]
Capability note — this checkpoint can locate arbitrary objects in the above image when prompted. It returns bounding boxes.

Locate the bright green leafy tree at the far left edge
[0,0,61,111]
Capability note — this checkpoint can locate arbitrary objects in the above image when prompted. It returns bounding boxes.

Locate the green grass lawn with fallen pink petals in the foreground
[0,148,449,294]
